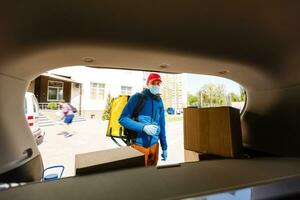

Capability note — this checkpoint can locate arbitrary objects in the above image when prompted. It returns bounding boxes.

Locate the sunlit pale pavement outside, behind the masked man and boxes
[39,119,184,177]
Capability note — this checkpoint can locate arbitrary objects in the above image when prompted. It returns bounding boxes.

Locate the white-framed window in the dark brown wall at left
[47,81,64,101]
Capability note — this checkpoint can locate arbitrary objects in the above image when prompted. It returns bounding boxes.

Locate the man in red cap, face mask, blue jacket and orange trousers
[119,73,168,166]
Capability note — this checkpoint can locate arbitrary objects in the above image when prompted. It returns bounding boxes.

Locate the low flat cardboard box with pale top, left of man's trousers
[75,147,145,175]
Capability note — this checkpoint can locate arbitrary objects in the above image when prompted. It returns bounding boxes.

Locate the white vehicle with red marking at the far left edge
[24,92,45,145]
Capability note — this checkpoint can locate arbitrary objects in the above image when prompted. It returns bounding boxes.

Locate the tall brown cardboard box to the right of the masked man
[184,107,242,158]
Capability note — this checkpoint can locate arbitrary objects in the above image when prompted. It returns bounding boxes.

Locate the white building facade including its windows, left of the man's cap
[50,66,143,113]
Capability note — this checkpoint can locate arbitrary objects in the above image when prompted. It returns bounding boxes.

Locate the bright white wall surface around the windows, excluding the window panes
[50,66,144,110]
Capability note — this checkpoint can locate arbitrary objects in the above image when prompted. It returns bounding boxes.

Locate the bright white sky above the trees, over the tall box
[184,74,240,94]
